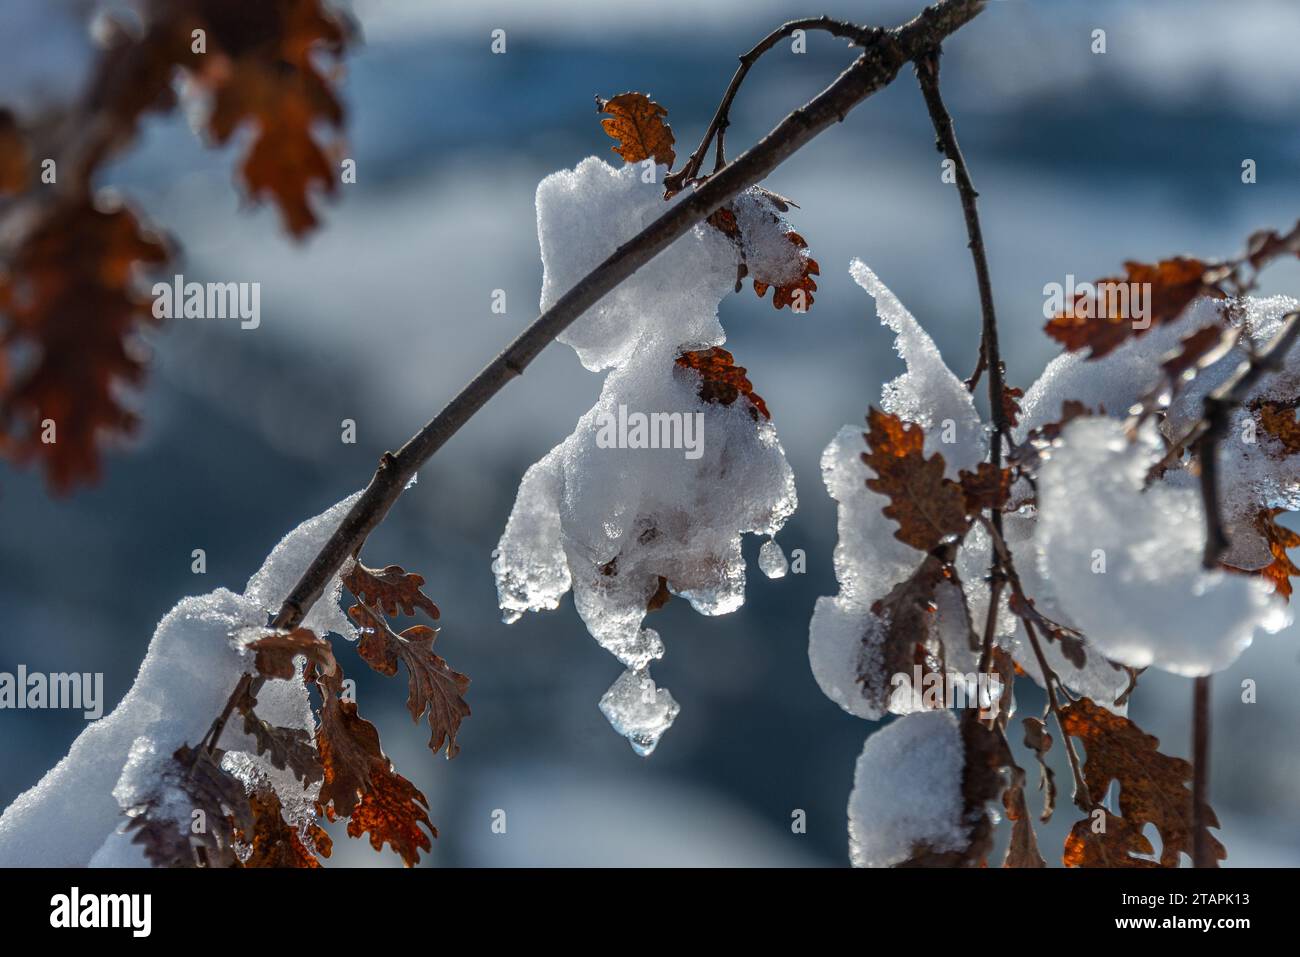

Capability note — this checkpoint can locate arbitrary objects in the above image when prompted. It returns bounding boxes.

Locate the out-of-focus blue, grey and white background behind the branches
[0,0,1300,866]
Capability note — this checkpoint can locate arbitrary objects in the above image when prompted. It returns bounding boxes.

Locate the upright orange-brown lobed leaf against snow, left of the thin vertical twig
[862,408,970,551]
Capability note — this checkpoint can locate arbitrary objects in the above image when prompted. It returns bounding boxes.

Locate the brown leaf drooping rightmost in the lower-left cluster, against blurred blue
[347,600,469,758]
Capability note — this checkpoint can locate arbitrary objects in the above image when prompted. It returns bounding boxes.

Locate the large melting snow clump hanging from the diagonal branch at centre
[493,159,796,753]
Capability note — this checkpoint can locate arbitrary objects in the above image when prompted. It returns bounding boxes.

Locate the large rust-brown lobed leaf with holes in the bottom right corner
[1061,698,1227,867]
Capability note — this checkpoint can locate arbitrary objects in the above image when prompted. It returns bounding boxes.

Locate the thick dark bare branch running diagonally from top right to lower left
[208,0,985,746]
